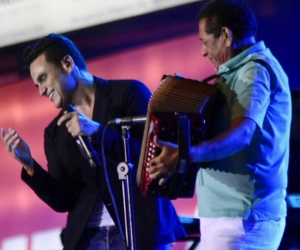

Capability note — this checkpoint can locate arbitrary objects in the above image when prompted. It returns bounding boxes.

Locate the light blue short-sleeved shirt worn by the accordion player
[196,41,291,220]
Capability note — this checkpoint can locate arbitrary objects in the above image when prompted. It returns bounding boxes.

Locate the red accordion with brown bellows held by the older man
[137,75,217,199]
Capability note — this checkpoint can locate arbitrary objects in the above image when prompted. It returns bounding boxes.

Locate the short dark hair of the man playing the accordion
[198,0,257,42]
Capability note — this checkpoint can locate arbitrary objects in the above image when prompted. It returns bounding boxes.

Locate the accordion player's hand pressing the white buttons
[149,135,178,185]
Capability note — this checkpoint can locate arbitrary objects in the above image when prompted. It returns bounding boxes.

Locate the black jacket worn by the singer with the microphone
[22,77,185,250]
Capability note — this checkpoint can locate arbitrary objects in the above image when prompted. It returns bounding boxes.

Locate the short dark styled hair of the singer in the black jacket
[23,33,87,72]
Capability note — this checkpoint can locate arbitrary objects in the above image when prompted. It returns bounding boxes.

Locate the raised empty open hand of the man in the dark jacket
[1,128,34,173]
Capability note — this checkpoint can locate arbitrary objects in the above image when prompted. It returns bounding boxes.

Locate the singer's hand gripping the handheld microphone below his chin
[57,110,100,137]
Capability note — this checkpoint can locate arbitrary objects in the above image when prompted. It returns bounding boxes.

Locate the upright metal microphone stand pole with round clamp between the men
[117,125,136,250]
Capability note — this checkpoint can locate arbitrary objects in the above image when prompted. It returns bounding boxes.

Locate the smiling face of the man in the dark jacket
[30,54,74,108]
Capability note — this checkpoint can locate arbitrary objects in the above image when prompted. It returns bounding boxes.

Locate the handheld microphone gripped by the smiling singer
[64,104,101,167]
